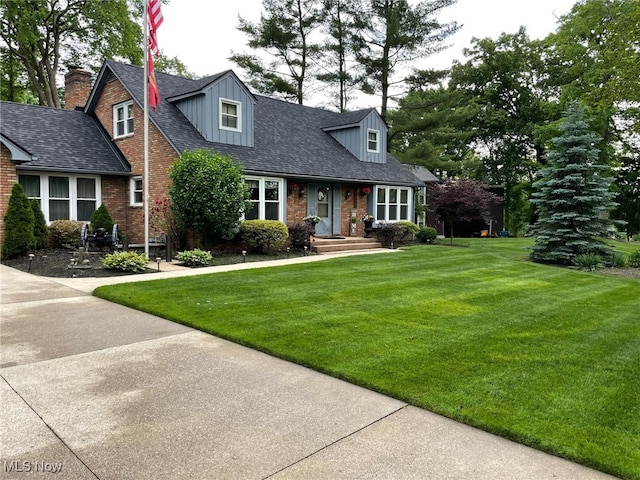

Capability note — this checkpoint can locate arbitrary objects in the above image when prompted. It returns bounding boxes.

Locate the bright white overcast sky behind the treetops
[158,0,577,106]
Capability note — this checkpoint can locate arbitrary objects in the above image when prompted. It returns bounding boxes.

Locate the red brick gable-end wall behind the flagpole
[95,80,178,243]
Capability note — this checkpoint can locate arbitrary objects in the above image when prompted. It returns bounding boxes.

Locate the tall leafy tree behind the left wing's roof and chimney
[0,0,143,107]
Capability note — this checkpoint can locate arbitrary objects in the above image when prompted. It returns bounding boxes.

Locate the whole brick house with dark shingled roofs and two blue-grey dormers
[0,60,424,243]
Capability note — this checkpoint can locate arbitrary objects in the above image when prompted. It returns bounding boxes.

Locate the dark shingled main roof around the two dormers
[95,60,423,186]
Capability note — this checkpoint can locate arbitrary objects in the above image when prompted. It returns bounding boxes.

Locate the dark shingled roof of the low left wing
[0,101,131,175]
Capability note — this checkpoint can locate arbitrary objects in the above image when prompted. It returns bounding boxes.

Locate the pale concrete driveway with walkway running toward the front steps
[0,256,612,480]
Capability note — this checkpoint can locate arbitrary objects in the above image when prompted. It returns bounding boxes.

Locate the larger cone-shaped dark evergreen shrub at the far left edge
[1,183,36,258]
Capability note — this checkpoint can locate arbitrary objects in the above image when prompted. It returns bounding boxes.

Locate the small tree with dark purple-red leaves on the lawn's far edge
[429,178,500,241]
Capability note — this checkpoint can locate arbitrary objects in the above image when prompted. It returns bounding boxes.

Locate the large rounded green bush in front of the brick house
[169,149,251,248]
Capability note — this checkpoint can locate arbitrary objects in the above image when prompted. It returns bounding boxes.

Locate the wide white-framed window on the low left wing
[18,173,101,222]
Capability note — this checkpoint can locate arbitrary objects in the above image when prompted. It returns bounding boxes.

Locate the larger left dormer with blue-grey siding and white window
[167,70,257,147]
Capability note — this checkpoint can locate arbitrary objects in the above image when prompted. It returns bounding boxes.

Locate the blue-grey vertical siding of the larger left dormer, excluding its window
[176,76,254,147]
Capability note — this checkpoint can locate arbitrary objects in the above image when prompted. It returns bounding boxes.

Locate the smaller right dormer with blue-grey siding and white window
[323,108,388,163]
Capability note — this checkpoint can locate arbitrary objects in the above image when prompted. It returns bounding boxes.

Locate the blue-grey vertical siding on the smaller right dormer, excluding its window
[328,114,387,163]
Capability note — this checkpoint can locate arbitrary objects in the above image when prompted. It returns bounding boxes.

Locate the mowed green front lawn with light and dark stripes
[96,239,640,479]
